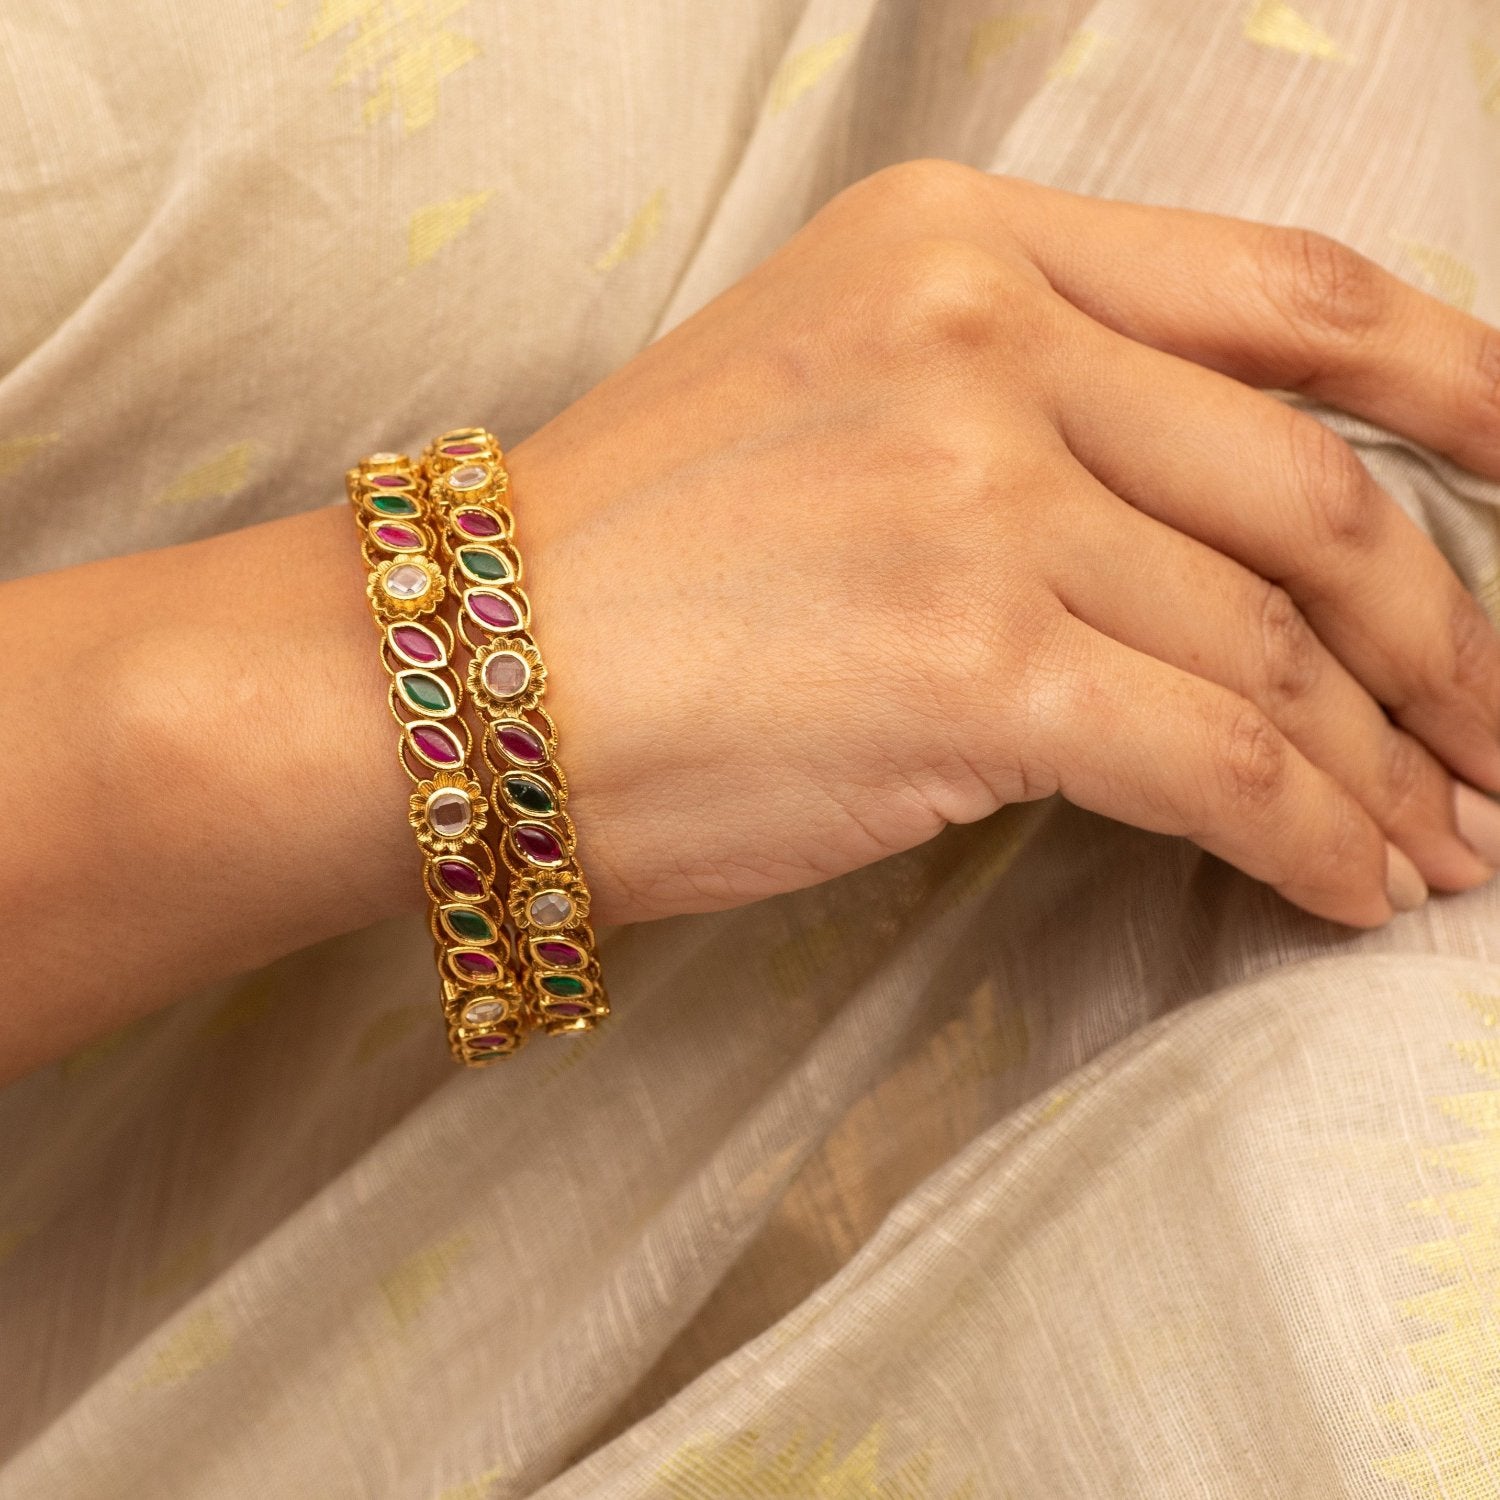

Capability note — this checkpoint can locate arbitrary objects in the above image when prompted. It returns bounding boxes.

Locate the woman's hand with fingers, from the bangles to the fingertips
[510,162,1500,926]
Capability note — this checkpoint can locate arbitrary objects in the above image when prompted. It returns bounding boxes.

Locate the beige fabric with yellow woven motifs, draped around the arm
[0,0,1500,1500]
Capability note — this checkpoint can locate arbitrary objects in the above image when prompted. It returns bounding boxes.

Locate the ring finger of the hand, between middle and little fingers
[1047,456,1494,891]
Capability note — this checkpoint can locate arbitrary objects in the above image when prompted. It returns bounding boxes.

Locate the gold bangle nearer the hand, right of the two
[422,428,609,1034]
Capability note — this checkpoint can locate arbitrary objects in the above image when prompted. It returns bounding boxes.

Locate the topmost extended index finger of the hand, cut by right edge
[990,177,1500,476]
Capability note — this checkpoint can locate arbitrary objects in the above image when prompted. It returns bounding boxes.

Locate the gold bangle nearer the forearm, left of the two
[345,453,534,1065]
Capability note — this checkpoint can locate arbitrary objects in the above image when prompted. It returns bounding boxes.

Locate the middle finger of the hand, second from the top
[1053,303,1500,792]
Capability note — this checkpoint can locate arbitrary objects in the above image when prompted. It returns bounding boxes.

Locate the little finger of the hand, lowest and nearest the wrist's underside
[1041,620,1427,927]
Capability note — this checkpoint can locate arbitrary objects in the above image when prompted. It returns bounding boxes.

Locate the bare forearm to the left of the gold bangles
[0,506,422,1080]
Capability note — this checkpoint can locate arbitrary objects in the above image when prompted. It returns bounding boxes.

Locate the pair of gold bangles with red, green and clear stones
[345,428,609,1067]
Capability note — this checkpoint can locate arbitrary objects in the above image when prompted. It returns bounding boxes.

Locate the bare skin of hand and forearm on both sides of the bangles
[0,162,1500,1077]
